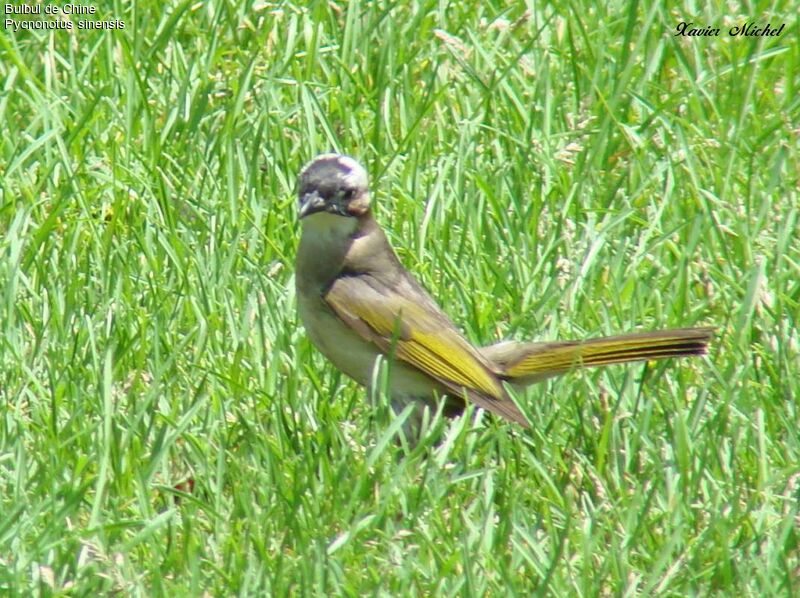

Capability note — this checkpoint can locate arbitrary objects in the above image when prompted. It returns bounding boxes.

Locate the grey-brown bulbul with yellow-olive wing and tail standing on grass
[295,153,714,427]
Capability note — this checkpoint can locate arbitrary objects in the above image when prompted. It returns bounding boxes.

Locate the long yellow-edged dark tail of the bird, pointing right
[481,327,714,386]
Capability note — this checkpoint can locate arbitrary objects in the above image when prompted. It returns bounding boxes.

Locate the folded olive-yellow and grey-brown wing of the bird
[324,274,528,426]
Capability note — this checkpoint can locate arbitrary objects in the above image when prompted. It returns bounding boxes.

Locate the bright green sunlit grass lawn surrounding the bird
[0,0,800,596]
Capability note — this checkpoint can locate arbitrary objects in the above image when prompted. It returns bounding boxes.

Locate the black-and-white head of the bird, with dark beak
[297,154,370,219]
